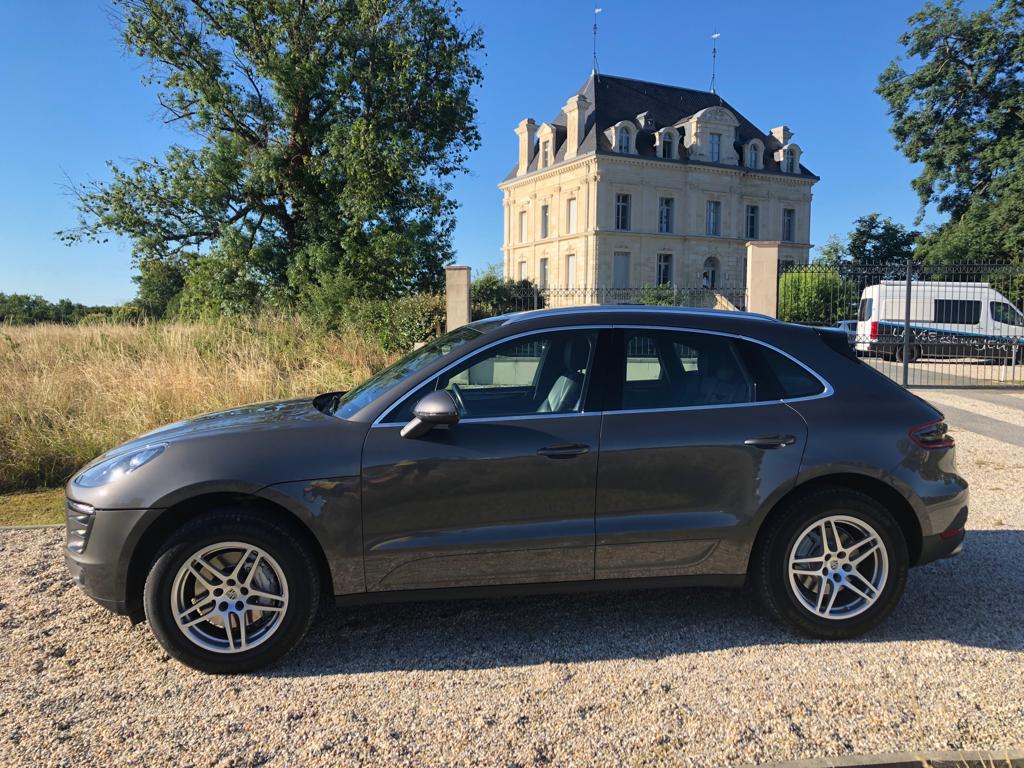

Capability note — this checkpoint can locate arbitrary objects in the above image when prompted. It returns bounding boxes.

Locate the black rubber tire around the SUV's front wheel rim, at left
[143,509,319,674]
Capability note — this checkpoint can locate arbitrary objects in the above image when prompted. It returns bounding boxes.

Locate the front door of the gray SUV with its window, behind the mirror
[362,329,601,591]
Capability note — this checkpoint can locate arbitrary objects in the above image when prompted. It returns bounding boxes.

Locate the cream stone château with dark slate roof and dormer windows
[499,75,818,300]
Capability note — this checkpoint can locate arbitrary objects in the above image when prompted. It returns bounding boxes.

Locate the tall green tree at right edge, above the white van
[878,0,1024,262]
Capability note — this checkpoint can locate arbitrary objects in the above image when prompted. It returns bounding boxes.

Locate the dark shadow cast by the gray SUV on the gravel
[260,529,1024,677]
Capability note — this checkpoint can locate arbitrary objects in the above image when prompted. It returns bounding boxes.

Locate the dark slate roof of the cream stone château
[504,74,818,181]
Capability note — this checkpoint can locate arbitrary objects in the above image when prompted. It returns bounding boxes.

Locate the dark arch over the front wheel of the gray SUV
[125,492,333,623]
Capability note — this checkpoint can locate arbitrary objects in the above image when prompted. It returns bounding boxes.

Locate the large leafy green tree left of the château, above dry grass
[60,0,482,313]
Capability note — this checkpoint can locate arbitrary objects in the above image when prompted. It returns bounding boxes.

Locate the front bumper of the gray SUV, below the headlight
[65,500,156,618]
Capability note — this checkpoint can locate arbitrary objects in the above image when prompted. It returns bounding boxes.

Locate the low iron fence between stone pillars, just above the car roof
[473,281,746,318]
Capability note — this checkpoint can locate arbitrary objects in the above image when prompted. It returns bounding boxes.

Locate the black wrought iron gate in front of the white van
[777,260,1024,387]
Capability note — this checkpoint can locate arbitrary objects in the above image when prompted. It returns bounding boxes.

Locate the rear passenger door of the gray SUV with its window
[595,328,826,579]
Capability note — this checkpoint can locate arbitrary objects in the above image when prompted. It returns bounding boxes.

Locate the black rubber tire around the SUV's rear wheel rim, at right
[751,487,909,640]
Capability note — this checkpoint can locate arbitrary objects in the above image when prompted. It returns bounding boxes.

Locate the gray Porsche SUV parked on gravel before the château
[67,306,968,672]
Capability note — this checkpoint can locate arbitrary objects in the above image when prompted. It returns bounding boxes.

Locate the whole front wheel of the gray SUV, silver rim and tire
[143,510,319,674]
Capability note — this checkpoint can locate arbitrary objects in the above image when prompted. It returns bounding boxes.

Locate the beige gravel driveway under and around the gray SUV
[0,432,1024,766]
